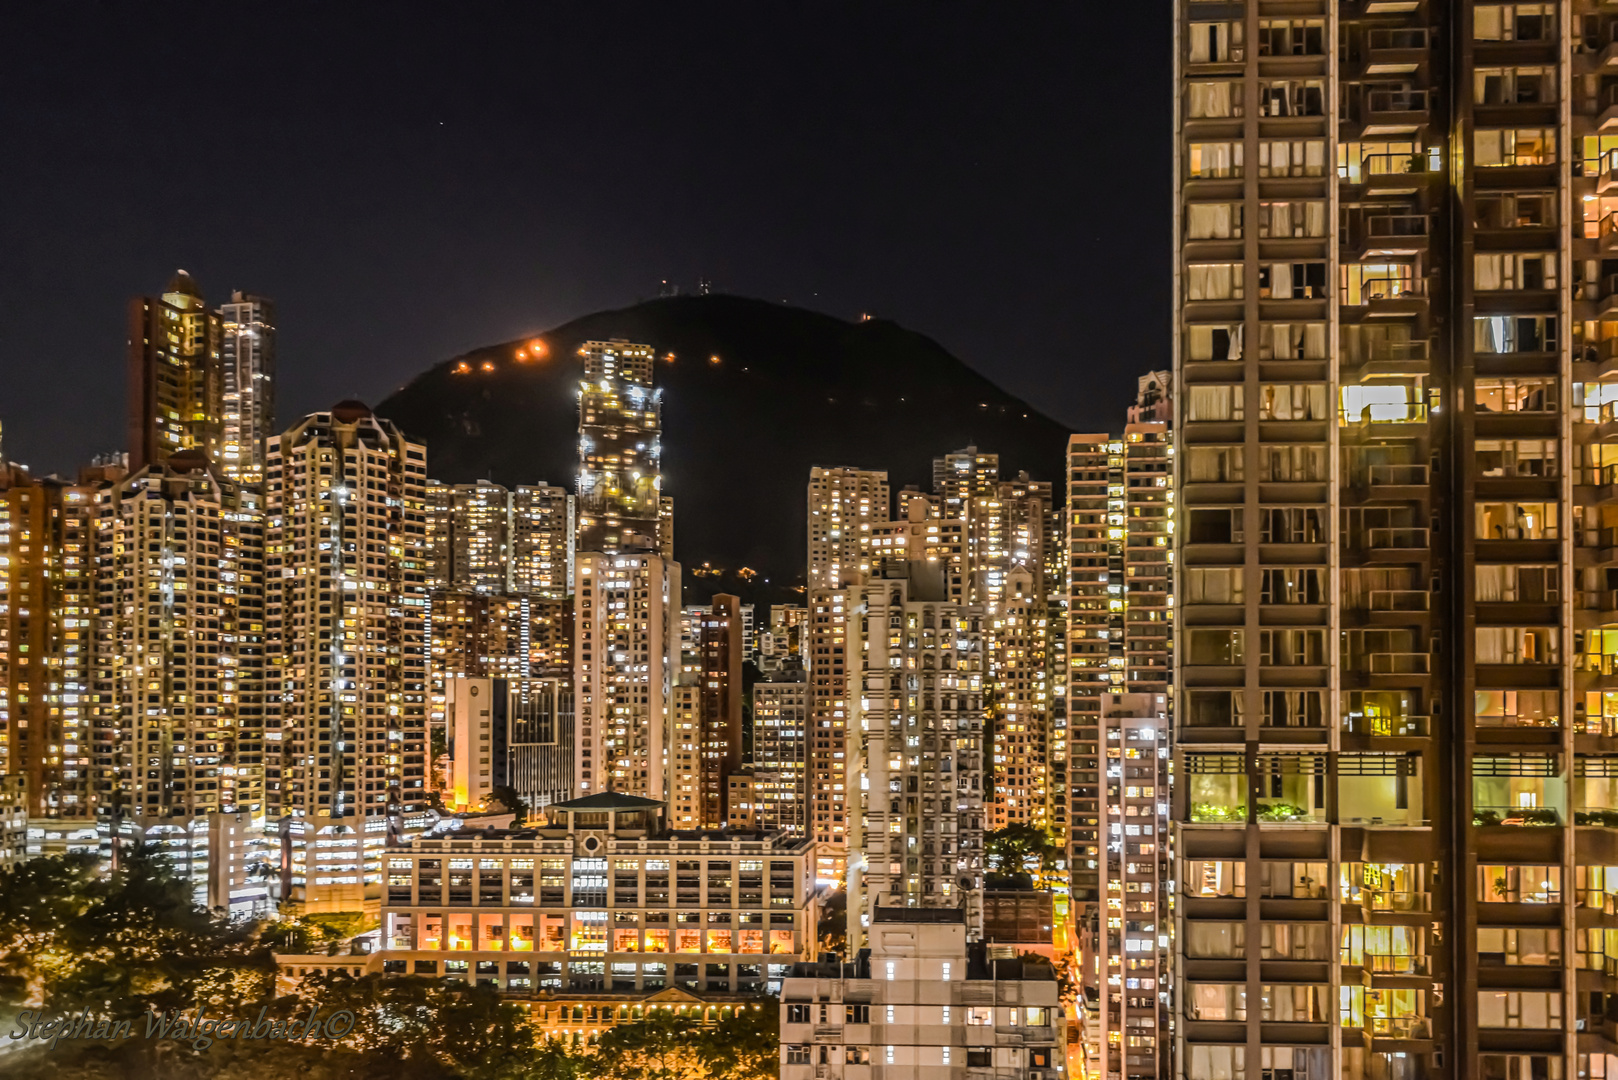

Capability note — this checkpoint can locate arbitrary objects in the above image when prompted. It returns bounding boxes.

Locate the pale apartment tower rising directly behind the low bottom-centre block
[848,563,985,949]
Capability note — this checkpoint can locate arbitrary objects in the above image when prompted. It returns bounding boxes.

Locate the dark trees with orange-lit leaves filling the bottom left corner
[0,850,778,1080]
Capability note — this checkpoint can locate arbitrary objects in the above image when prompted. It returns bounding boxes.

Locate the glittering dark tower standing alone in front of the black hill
[578,340,660,559]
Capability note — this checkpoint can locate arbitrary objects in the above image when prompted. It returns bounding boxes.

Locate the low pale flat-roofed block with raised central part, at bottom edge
[781,907,1066,1080]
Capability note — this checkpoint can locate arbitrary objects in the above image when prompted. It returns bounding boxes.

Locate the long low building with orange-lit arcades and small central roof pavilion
[372,792,817,1033]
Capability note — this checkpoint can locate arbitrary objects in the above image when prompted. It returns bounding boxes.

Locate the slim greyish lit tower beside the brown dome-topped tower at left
[218,290,275,487]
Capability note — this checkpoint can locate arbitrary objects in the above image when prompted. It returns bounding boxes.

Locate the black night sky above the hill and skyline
[0,0,1170,470]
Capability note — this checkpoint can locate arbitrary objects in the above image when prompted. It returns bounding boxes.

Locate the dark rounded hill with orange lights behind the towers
[377,296,1066,602]
